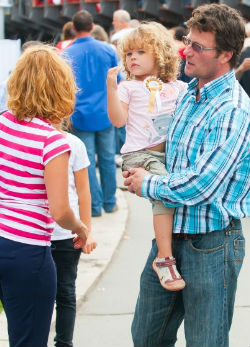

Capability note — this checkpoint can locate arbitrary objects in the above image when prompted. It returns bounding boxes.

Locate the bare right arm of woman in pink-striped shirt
[44,153,88,248]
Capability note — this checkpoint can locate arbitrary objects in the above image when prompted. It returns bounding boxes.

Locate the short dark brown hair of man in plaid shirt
[187,4,245,68]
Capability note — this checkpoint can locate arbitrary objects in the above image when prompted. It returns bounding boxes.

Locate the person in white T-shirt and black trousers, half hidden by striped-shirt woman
[51,124,96,346]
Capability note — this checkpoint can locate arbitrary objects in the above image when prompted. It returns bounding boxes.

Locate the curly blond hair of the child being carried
[118,22,180,83]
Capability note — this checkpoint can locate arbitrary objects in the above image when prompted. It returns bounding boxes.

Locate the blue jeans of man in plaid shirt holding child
[132,220,245,347]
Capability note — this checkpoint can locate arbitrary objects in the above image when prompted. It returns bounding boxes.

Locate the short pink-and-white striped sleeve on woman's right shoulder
[43,131,71,165]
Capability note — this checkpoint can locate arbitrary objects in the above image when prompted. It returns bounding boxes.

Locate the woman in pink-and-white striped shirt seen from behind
[0,45,92,347]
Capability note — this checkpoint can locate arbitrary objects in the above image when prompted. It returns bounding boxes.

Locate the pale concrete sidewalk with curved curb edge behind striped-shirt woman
[0,189,128,347]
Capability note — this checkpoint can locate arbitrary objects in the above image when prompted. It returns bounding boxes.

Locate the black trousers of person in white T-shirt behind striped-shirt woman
[52,239,81,347]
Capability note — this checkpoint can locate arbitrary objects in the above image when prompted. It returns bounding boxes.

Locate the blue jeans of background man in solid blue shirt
[73,125,116,216]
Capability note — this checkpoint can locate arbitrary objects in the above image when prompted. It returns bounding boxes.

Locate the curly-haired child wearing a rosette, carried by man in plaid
[107,22,186,291]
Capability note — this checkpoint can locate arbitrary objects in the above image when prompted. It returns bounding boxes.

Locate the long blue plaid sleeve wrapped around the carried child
[141,109,250,207]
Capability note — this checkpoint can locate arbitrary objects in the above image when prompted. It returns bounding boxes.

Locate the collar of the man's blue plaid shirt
[188,70,236,98]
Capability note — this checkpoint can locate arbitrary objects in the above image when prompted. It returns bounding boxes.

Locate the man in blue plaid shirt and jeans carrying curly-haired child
[124,4,250,347]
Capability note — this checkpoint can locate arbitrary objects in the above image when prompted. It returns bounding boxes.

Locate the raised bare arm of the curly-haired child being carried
[107,66,128,128]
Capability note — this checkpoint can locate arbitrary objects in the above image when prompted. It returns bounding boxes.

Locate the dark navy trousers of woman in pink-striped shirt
[0,237,56,347]
